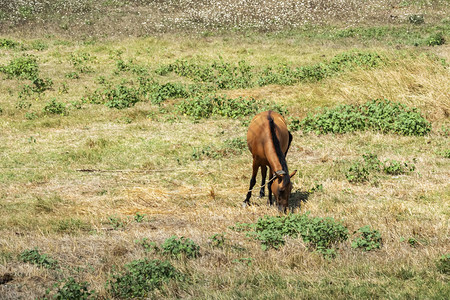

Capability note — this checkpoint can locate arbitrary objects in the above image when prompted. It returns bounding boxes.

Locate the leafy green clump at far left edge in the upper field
[0,55,39,80]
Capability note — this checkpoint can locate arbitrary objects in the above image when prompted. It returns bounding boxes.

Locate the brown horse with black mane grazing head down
[244,110,297,212]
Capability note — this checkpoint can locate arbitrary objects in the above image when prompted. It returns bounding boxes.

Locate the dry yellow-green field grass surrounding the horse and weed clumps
[0,1,450,299]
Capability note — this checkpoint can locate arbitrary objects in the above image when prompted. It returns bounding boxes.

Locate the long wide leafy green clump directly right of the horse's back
[297,100,431,136]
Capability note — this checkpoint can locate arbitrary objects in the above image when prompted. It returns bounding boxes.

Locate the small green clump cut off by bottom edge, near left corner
[44,277,95,300]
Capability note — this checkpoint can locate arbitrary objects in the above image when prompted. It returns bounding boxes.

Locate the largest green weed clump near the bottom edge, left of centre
[107,258,181,299]
